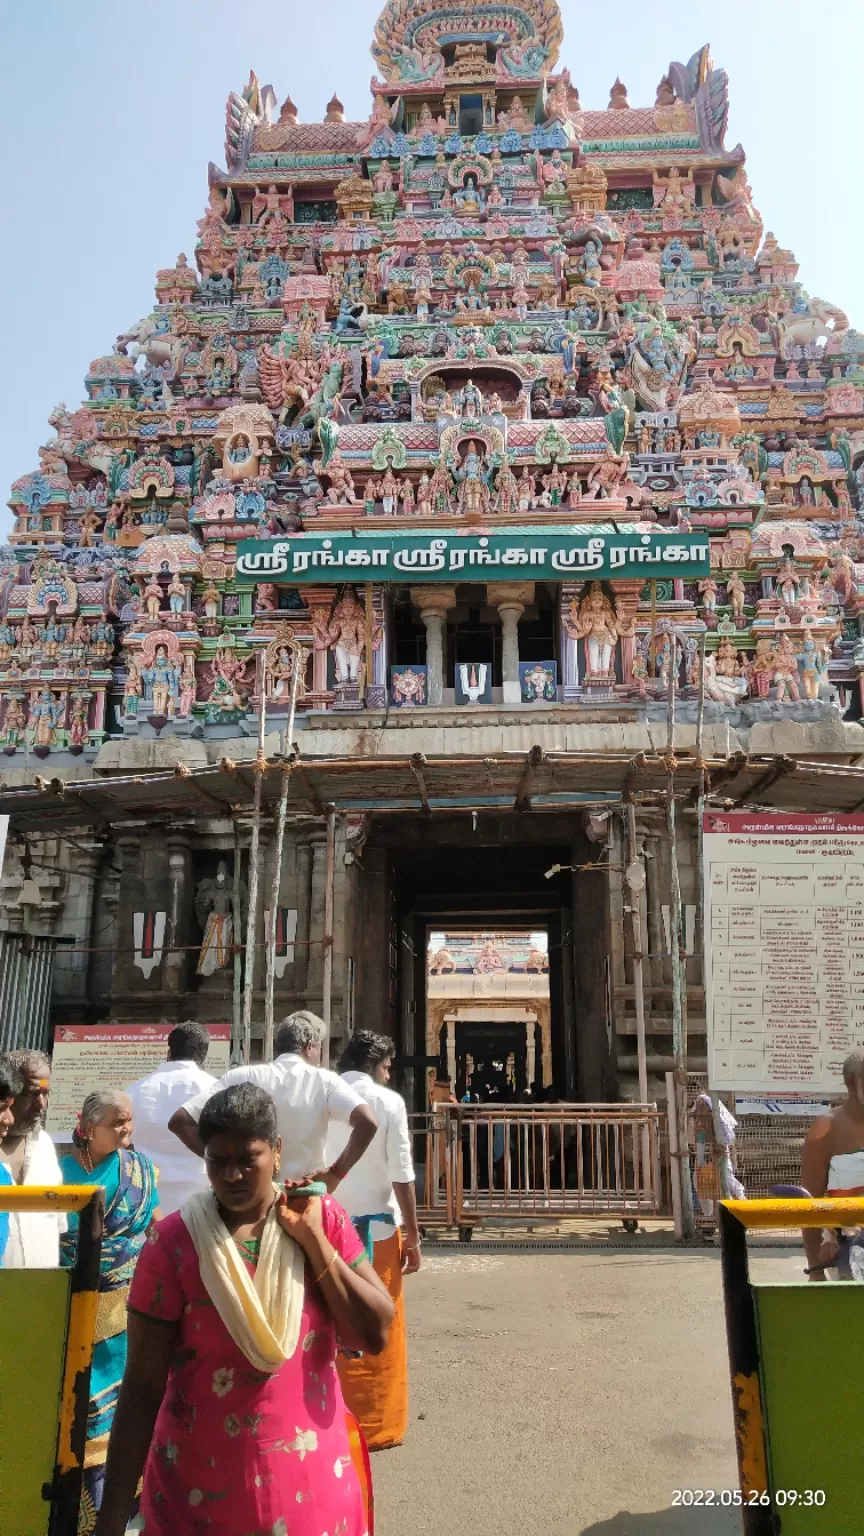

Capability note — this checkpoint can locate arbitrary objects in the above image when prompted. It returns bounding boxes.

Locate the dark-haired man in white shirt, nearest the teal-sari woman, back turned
[126,1021,218,1217]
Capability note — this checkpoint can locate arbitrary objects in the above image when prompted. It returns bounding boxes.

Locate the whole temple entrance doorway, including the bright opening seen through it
[355,808,618,1112]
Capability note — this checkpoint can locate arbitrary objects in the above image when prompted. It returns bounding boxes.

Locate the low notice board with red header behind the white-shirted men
[45,1025,231,1141]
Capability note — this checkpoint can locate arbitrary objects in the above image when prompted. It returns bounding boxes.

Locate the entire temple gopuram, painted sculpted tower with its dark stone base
[0,0,864,1104]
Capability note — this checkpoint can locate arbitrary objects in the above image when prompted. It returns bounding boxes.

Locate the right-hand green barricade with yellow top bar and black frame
[719,1200,864,1536]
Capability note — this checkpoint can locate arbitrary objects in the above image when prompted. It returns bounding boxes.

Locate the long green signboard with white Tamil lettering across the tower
[237,522,710,587]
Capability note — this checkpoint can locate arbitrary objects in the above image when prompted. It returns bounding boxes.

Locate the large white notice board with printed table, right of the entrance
[703,811,864,1097]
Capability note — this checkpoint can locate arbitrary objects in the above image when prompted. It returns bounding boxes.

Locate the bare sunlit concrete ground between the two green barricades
[374,1243,801,1536]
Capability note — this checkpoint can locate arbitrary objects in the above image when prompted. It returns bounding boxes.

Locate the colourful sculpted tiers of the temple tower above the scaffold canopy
[0,0,864,1081]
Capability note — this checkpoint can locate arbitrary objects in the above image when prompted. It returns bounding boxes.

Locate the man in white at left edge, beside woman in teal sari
[0,1051,66,1269]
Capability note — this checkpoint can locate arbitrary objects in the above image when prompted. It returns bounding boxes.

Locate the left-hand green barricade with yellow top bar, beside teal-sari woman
[0,1186,105,1536]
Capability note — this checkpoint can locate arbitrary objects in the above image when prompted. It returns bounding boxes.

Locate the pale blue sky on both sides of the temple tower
[0,0,864,531]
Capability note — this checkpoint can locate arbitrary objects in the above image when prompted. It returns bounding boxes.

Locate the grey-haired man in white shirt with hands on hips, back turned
[169,1009,378,1192]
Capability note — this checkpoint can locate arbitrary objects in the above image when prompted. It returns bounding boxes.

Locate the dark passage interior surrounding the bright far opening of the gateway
[357,809,618,1111]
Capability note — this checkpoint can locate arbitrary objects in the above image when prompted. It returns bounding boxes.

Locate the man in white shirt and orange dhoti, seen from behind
[327,1029,420,1450]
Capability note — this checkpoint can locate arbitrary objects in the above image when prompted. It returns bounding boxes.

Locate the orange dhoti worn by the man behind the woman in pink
[338,1232,407,1450]
